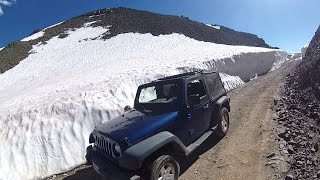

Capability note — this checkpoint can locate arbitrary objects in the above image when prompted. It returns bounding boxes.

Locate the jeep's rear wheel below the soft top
[216,107,230,137]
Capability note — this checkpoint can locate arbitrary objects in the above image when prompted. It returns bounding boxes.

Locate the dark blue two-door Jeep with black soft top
[86,71,230,180]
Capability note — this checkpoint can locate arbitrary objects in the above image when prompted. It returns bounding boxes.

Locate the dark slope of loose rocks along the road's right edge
[276,28,320,179]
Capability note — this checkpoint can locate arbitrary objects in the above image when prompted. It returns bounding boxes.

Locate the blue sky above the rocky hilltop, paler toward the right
[0,0,320,52]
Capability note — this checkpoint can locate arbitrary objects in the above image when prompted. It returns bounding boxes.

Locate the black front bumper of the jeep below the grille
[86,146,131,180]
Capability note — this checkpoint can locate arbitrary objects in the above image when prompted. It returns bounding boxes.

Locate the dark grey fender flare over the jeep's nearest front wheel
[119,131,187,170]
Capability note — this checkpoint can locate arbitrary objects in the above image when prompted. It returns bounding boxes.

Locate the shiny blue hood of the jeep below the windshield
[95,110,178,147]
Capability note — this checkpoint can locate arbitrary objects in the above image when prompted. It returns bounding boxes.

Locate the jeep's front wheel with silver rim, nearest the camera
[142,155,180,180]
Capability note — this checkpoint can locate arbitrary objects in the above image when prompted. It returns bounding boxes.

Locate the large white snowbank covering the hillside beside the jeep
[0,24,286,179]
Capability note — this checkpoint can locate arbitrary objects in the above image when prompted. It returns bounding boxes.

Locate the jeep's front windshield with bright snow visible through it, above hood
[135,83,180,113]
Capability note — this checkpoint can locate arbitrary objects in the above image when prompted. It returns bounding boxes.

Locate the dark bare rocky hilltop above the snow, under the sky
[0,8,271,74]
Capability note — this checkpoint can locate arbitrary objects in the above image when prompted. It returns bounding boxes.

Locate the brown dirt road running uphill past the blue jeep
[51,63,295,180]
